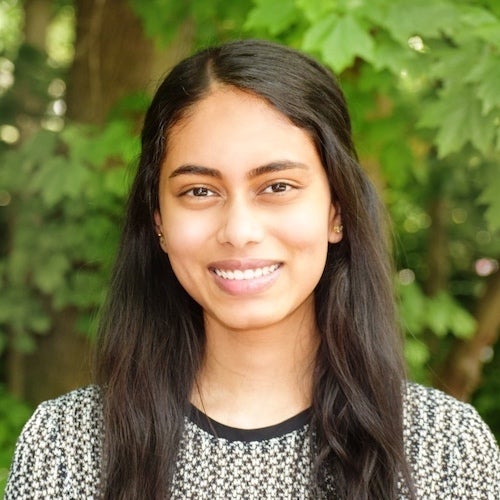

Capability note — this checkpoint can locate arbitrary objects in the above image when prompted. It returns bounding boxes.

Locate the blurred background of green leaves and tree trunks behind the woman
[0,0,500,492]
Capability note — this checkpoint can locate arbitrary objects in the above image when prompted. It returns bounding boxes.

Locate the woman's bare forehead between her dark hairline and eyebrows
[166,87,315,170]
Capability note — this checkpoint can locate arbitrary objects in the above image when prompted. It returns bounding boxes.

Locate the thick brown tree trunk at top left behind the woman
[67,0,156,123]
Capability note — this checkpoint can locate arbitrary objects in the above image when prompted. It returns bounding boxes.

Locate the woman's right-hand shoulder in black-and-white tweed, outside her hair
[404,383,500,498]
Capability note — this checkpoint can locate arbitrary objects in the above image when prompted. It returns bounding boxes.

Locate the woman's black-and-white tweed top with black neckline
[5,384,500,500]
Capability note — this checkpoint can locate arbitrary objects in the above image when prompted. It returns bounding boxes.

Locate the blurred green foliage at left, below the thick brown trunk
[0,119,139,352]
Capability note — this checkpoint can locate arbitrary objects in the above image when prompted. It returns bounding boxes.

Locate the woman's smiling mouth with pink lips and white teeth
[208,259,283,296]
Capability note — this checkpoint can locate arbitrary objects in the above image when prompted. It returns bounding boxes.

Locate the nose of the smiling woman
[217,199,264,248]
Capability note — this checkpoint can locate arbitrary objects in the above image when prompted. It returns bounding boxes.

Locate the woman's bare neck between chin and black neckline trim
[192,314,319,428]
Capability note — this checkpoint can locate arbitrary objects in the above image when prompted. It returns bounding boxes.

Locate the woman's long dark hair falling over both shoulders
[97,40,411,499]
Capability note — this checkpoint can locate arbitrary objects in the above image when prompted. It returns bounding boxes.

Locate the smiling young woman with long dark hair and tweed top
[7,40,500,500]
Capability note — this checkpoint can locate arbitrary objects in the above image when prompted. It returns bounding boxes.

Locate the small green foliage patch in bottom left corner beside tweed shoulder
[0,385,32,496]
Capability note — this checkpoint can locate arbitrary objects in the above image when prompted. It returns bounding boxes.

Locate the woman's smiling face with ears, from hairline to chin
[155,87,341,330]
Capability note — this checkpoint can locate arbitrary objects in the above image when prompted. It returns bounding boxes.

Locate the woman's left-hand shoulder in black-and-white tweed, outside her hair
[5,386,102,499]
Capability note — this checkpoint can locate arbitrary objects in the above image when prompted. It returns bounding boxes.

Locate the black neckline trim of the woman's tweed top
[189,405,311,442]
